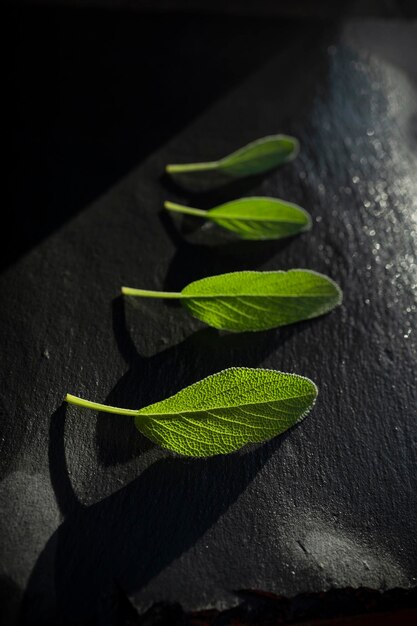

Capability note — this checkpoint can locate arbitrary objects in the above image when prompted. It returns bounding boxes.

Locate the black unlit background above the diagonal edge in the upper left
[5,0,417,268]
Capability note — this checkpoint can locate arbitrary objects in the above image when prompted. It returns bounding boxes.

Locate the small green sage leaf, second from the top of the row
[164,197,311,239]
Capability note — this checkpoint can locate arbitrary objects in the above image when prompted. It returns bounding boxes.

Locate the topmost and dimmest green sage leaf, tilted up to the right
[166,135,299,191]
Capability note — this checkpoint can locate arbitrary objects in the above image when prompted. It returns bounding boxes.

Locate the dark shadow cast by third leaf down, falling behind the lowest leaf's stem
[96,296,304,467]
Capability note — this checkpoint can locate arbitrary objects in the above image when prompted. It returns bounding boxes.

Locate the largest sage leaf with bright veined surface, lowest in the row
[65,367,317,457]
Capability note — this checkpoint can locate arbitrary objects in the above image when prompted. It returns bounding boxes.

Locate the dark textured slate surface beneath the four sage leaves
[0,17,417,624]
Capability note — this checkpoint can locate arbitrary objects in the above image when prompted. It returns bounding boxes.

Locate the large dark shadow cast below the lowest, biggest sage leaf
[20,358,296,623]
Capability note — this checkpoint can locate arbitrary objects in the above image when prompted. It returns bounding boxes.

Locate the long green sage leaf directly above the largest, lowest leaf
[122,269,342,332]
